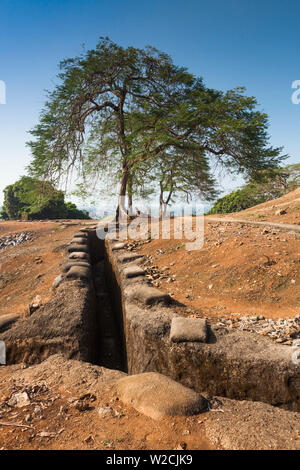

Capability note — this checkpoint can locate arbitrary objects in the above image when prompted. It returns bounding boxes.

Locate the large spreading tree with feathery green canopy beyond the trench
[29,38,283,218]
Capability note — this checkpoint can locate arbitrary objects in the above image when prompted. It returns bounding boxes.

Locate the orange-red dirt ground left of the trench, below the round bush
[0,221,90,316]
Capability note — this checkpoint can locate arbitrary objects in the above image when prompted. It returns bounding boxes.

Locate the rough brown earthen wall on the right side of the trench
[106,235,300,411]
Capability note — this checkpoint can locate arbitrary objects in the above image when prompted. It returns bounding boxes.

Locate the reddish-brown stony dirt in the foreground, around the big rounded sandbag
[0,354,300,450]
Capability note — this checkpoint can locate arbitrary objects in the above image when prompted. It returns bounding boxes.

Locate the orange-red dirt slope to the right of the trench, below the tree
[135,189,300,319]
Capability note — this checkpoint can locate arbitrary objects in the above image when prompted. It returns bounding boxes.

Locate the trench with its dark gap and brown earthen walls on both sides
[0,229,300,411]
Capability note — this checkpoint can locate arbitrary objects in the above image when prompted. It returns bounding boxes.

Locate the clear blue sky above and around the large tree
[0,0,300,202]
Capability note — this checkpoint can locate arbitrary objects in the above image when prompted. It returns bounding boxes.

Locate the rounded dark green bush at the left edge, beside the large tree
[2,176,89,219]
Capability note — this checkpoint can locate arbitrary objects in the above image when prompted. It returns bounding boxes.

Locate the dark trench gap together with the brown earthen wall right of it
[85,231,300,411]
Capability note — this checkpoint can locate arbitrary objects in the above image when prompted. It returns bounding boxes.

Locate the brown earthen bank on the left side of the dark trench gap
[0,281,96,364]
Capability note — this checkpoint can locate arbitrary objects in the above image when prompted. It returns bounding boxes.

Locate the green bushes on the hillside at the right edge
[208,164,300,214]
